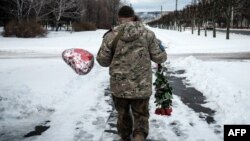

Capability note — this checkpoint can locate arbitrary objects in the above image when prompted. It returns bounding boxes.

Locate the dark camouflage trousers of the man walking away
[113,96,149,139]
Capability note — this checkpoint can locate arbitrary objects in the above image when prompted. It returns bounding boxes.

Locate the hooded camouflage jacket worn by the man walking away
[96,22,167,99]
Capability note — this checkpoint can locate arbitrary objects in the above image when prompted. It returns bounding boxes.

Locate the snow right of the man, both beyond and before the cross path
[148,26,250,122]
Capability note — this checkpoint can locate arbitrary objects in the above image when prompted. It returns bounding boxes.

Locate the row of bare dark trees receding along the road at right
[149,0,250,39]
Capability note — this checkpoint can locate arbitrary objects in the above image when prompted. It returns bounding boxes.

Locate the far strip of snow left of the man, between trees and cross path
[0,30,106,55]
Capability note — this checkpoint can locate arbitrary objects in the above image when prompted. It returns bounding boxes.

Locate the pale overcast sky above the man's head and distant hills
[125,0,192,12]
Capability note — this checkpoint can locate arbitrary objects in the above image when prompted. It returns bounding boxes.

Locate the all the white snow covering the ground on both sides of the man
[0,28,250,141]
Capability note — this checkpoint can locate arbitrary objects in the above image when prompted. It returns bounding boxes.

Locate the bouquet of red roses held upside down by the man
[153,64,173,116]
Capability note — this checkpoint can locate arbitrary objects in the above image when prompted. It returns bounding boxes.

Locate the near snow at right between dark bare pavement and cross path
[171,56,250,125]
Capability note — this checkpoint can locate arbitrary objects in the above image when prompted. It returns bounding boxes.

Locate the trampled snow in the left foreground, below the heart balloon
[0,58,111,140]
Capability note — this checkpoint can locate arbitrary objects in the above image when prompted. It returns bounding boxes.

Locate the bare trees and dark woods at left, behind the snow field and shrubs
[0,0,121,30]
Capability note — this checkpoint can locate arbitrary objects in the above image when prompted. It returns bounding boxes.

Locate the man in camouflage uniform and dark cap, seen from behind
[97,6,167,141]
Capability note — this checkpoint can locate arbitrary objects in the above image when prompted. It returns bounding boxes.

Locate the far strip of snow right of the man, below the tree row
[149,29,250,54]
